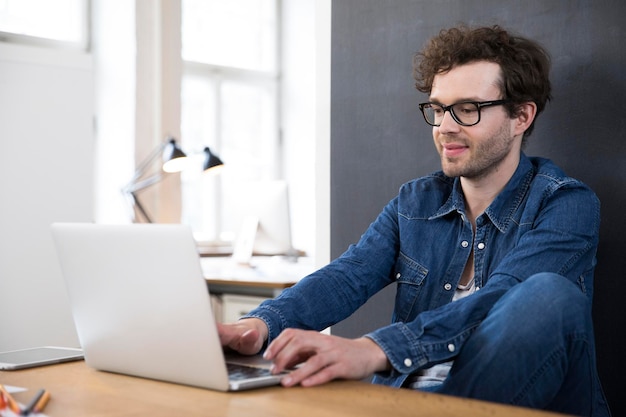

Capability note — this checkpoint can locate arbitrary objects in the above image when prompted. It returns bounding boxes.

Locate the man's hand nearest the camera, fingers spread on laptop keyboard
[264,329,390,386]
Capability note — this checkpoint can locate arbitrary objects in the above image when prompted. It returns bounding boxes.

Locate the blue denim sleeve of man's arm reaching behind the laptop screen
[245,195,399,342]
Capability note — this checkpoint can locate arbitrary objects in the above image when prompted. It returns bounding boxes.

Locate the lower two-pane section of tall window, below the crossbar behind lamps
[181,75,277,239]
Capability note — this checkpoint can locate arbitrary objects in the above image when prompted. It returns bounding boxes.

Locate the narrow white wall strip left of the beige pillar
[91,0,137,223]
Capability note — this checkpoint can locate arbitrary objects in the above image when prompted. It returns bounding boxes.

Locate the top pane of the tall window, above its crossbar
[182,0,277,71]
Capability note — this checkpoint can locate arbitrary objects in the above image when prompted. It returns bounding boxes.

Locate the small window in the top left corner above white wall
[0,0,89,49]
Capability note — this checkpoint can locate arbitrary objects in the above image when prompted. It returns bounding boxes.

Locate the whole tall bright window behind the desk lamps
[181,0,281,240]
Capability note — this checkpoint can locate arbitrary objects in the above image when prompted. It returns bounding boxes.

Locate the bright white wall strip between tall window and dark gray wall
[281,0,331,266]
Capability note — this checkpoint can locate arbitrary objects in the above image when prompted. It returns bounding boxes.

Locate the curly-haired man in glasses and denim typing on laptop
[219,26,609,416]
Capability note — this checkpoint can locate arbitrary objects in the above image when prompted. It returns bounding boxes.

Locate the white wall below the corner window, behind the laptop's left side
[0,43,94,350]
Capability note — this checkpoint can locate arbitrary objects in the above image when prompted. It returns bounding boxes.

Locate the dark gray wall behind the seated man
[331,0,626,415]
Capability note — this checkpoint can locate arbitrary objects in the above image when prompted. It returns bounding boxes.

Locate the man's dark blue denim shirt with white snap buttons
[241,154,600,386]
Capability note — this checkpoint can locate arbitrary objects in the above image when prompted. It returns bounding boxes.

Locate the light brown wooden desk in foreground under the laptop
[0,361,555,417]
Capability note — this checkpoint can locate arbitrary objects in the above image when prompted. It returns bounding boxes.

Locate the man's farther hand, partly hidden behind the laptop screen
[217,318,268,355]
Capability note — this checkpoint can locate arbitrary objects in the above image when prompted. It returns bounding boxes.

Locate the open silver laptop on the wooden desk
[51,223,282,391]
